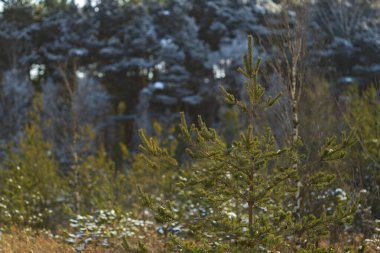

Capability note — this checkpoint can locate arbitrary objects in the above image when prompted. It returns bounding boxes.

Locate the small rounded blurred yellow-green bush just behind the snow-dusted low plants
[67,145,128,214]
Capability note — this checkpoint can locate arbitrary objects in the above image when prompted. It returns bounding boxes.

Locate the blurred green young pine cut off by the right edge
[345,86,380,231]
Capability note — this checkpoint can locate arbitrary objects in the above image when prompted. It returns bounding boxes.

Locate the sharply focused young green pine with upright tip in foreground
[140,36,353,252]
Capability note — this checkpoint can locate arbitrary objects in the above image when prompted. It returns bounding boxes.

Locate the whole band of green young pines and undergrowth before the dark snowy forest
[0,37,380,252]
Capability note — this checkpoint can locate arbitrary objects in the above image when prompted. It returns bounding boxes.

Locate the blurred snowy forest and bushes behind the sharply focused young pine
[0,0,380,252]
